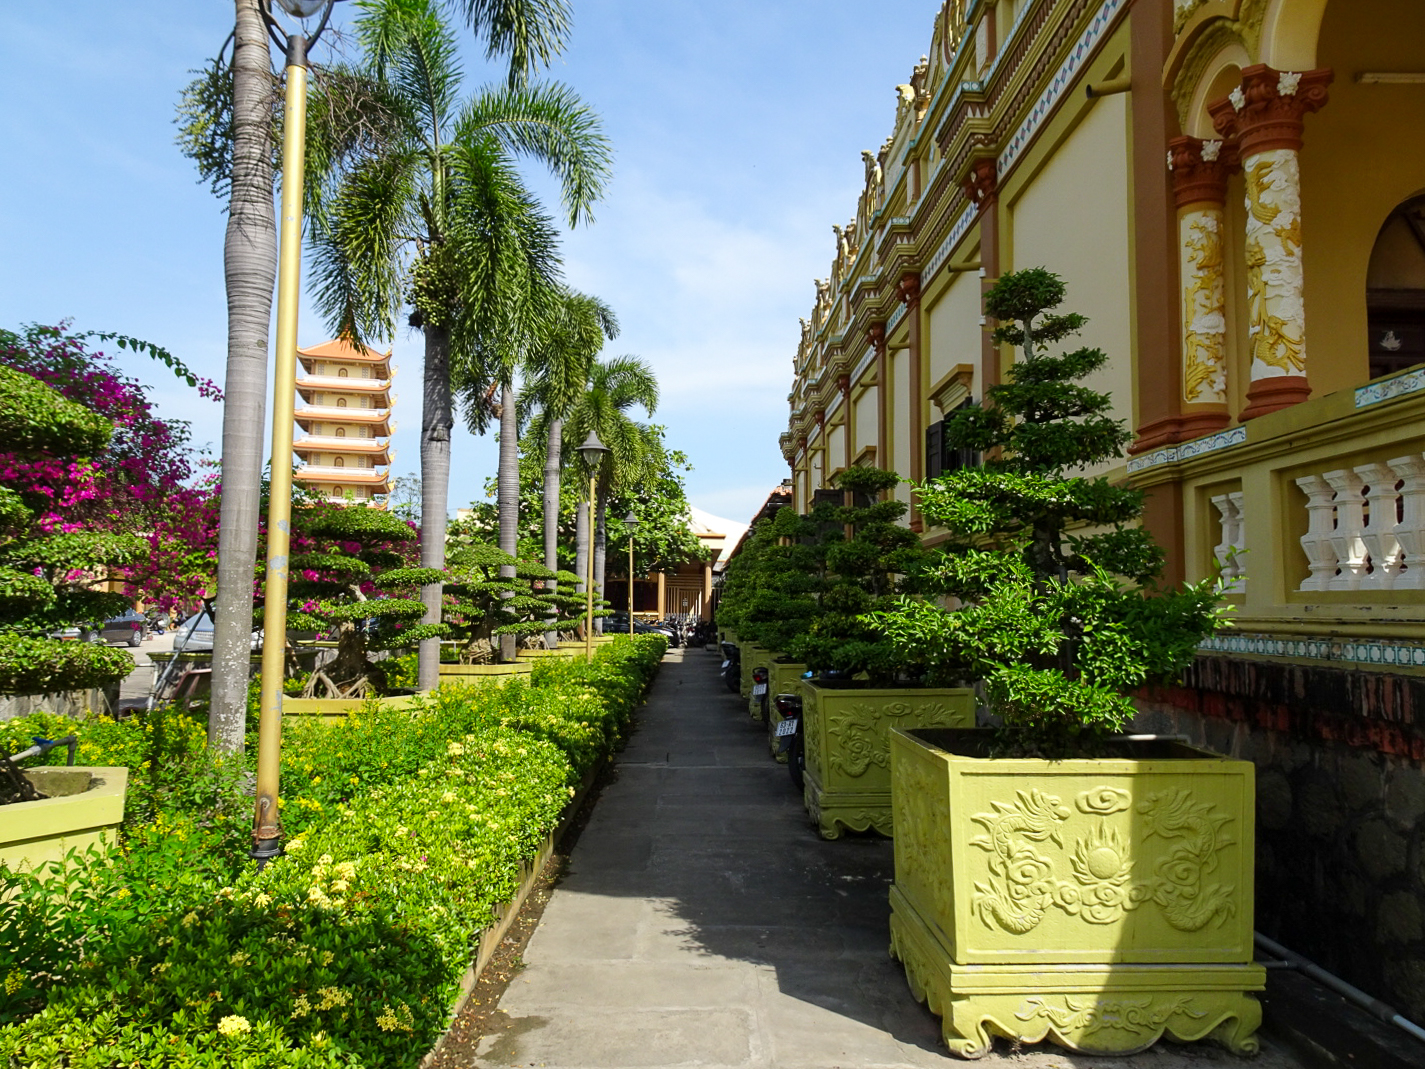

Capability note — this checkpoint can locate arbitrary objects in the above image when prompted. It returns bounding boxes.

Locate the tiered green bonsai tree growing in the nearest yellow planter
[872,268,1218,757]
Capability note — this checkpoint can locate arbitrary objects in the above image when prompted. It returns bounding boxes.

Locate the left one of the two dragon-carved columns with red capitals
[1168,137,1237,442]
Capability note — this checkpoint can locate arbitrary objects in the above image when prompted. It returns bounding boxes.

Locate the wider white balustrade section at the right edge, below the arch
[1299,453,1425,590]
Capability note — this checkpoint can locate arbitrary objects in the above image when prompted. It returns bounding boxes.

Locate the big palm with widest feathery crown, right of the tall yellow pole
[312,0,610,690]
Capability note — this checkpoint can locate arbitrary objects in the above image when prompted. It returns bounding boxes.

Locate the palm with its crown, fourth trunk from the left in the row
[521,289,618,647]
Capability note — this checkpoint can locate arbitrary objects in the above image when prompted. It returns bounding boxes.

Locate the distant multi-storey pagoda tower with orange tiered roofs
[292,341,395,502]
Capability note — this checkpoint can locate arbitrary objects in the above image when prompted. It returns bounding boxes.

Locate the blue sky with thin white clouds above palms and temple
[0,0,939,530]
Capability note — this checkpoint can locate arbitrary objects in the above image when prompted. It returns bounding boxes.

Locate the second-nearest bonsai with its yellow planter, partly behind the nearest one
[778,468,975,838]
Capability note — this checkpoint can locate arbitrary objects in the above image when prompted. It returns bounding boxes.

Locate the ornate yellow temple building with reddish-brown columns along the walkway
[781,0,1425,1018]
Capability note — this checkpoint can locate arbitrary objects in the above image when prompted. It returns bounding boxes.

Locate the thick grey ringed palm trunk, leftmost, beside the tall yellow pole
[208,0,275,753]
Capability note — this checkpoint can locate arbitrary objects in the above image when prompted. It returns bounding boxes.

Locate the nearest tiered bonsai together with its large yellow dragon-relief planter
[876,269,1264,1058]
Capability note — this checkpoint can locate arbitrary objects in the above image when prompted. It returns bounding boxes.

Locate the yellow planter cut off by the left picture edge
[0,767,128,869]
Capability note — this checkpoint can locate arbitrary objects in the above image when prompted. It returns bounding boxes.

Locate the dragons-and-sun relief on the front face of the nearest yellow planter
[970,787,1237,935]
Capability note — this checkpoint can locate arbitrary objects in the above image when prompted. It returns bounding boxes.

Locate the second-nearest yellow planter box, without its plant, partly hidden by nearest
[801,680,975,840]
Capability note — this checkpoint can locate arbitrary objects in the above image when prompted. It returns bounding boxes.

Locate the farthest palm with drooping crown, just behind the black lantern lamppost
[564,356,663,632]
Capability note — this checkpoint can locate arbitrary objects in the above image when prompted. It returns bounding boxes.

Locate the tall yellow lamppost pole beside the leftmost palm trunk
[252,50,306,862]
